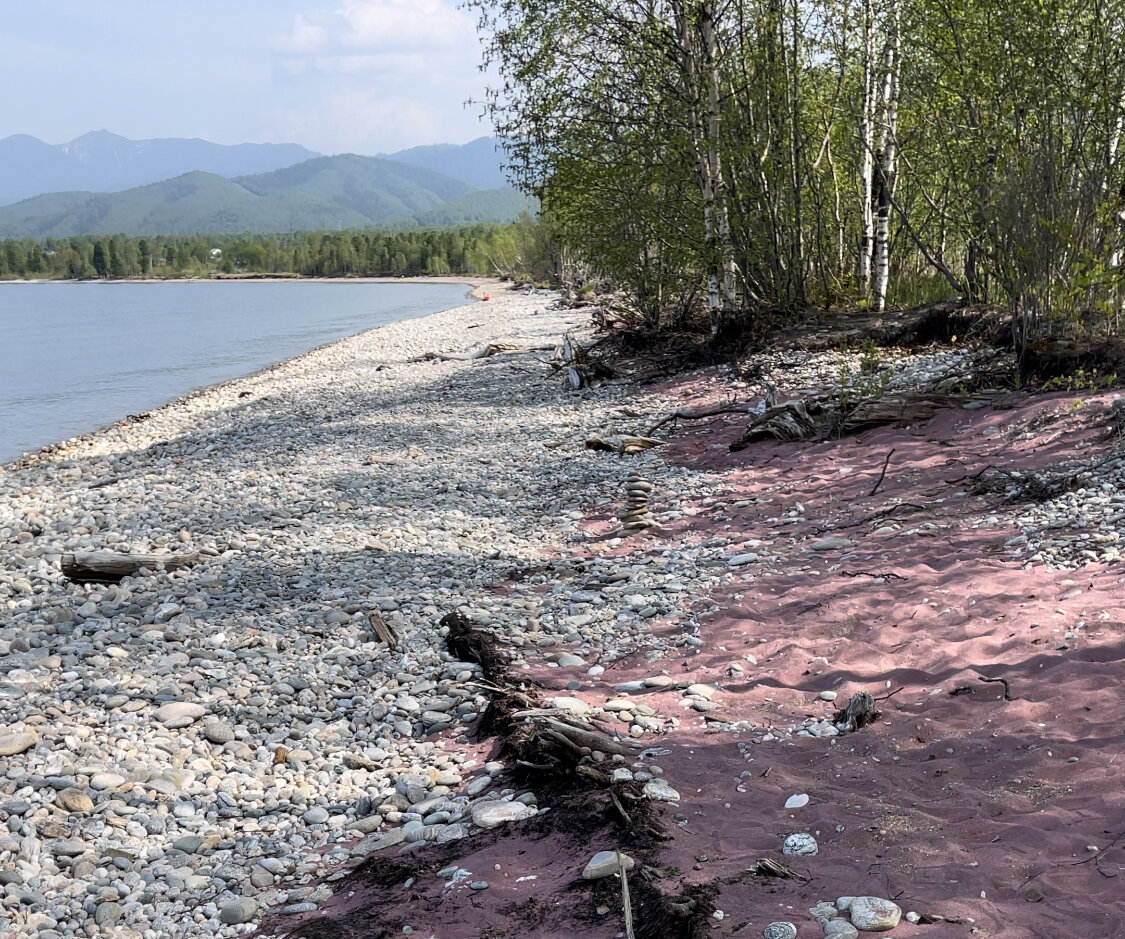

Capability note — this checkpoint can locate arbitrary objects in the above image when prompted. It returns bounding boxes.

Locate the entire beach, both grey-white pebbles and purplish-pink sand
[0,287,1125,939]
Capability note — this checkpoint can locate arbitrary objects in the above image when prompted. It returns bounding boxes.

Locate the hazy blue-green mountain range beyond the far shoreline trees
[0,132,522,238]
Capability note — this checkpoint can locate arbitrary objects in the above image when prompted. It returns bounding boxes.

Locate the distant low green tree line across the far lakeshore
[0,216,550,280]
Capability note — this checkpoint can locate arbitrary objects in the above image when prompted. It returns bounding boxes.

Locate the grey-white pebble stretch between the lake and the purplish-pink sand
[0,288,652,939]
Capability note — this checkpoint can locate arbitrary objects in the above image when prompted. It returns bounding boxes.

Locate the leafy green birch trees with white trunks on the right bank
[468,0,1125,353]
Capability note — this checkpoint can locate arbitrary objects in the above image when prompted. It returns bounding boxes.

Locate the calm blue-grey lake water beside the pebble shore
[0,281,469,463]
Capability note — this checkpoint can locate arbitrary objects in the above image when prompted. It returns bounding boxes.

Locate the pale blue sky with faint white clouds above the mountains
[0,0,491,154]
